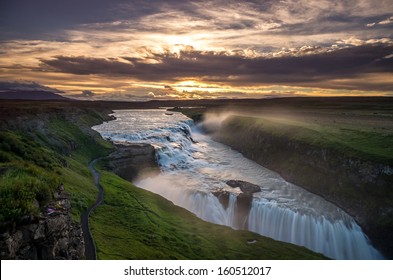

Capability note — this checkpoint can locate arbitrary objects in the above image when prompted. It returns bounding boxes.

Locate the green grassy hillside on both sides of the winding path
[0,103,324,259]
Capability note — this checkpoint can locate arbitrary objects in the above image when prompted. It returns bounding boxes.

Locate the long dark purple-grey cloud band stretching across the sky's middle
[42,44,393,90]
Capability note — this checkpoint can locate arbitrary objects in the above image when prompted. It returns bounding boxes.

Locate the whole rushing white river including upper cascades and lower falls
[93,110,382,259]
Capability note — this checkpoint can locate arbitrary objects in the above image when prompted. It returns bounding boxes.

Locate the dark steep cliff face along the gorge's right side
[213,117,393,257]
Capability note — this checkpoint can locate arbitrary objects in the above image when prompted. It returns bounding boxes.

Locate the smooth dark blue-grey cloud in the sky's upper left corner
[0,0,176,39]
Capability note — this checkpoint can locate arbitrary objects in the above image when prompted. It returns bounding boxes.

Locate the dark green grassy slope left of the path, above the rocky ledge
[0,108,112,230]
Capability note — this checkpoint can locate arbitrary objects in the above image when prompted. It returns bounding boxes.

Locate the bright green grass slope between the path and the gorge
[91,168,324,259]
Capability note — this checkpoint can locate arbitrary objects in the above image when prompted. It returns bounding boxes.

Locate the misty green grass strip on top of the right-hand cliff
[226,116,393,164]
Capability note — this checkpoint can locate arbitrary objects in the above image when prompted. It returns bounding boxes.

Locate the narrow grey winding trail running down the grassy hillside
[81,158,104,260]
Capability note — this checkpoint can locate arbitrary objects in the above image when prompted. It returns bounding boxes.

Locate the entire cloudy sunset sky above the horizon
[0,0,393,100]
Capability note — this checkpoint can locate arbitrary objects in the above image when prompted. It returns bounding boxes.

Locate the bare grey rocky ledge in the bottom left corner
[0,186,84,260]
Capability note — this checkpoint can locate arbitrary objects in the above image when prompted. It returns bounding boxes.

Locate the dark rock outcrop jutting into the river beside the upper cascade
[109,142,159,181]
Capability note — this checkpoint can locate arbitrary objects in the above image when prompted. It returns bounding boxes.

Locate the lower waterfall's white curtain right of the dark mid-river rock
[248,200,382,259]
